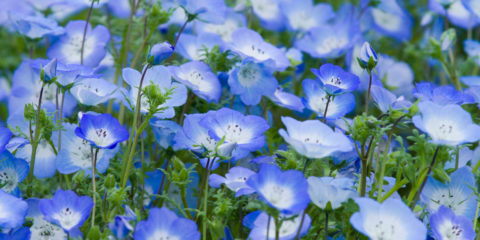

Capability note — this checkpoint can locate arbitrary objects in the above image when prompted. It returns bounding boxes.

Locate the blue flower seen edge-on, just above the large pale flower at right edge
[413,82,474,105]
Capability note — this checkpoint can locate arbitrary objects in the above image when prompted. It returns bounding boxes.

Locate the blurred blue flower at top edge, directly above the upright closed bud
[369,0,413,41]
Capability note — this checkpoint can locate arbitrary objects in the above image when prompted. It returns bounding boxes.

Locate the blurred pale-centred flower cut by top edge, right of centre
[280,0,335,31]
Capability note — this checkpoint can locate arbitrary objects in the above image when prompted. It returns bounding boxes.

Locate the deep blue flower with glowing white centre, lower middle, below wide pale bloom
[247,164,310,214]
